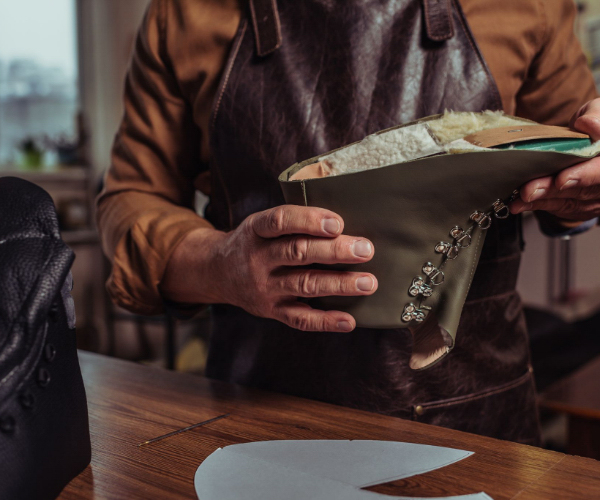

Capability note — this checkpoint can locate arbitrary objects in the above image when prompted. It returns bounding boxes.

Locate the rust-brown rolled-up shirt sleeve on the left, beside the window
[97,0,218,314]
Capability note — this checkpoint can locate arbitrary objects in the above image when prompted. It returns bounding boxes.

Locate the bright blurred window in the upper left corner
[0,0,79,168]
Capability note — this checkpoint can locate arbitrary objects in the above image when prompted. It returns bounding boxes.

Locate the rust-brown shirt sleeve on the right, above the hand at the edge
[516,0,598,126]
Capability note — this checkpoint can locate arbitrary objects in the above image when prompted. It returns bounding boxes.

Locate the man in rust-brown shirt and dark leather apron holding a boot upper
[99,0,600,443]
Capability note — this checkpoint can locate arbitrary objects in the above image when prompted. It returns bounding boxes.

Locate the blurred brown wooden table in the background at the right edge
[540,358,600,459]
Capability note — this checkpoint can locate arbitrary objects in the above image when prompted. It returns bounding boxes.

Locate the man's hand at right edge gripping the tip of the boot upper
[510,99,600,223]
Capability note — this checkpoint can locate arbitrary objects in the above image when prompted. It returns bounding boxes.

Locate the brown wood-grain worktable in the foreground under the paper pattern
[60,353,600,500]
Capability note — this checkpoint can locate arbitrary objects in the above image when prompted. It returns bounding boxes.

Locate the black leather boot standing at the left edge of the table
[0,177,91,500]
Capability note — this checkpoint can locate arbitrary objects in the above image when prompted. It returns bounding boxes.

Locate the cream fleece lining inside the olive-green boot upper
[319,111,600,176]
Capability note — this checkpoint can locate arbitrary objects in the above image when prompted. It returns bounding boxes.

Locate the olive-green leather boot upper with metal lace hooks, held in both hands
[279,117,589,365]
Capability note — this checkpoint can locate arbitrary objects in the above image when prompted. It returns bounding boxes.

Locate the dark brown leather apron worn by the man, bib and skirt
[206,0,539,444]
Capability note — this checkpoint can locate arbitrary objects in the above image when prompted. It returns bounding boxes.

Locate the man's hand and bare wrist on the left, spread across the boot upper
[161,205,377,332]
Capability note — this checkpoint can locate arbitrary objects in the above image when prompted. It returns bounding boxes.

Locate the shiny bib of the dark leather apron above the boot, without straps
[205,0,501,229]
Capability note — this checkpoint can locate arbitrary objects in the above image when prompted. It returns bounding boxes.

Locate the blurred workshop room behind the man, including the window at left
[0,0,600,458]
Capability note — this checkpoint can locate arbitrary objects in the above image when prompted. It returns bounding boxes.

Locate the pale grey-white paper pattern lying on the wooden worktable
[194,440,491,500]
